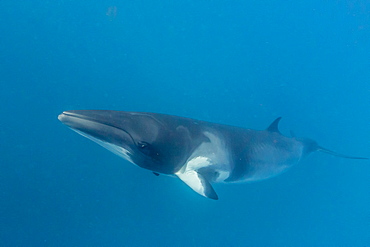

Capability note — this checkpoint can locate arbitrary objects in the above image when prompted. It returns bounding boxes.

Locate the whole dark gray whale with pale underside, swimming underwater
[58,110,367,199]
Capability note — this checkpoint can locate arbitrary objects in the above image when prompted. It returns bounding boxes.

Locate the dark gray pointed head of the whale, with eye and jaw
[58,110,197,174]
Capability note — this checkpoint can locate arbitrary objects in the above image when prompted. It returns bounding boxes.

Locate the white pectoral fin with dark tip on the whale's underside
[176,170,218,200]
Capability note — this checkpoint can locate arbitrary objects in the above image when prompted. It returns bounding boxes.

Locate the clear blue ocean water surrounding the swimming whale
[0,0,370,246]
